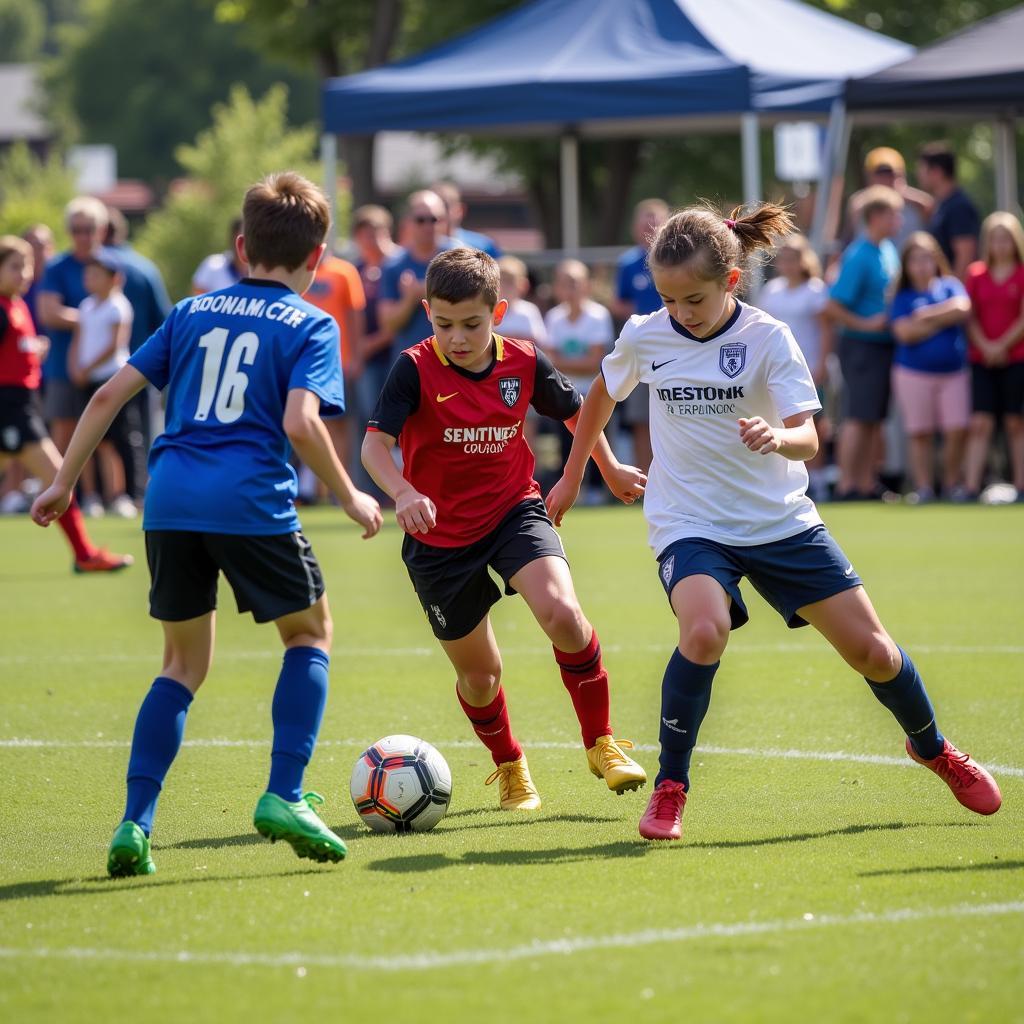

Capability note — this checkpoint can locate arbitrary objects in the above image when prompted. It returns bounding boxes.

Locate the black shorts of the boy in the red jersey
[401,498,565,640]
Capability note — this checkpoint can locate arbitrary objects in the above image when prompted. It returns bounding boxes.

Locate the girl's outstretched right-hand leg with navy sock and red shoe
[798,587,1001,814]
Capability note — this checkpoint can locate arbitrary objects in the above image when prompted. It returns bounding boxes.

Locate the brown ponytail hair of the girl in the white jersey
[647,203,793,281]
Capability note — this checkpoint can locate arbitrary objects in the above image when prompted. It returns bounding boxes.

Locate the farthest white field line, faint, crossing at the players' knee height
[0,639,1024,667]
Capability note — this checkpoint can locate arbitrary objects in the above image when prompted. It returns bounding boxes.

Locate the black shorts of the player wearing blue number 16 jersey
[145,529,324,623]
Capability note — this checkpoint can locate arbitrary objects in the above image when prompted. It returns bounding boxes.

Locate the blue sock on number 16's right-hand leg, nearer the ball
[266,647,331,803]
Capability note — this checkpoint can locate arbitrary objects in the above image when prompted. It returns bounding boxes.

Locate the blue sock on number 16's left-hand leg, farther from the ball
[122,676,193,836]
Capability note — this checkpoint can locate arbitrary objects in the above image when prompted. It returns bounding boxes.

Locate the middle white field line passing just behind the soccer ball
[0,736,1024,778]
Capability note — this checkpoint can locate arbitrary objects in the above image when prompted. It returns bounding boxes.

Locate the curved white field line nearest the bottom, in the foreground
[0,901,1024,976]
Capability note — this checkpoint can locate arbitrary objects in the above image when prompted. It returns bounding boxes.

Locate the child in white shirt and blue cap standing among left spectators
[68,249,142,518]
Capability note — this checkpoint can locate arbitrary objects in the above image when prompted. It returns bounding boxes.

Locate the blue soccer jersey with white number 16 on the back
[130,278,344,536]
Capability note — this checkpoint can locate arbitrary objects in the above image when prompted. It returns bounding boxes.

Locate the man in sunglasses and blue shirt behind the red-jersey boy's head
[377,190,457,362]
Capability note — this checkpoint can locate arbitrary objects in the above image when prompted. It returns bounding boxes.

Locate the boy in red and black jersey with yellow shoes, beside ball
[362,249,647,810]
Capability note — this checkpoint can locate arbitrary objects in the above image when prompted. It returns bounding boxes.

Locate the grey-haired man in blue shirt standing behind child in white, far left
[36,196,106,454]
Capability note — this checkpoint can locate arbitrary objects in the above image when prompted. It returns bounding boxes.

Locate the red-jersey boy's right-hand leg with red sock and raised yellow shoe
[509,557,647,794]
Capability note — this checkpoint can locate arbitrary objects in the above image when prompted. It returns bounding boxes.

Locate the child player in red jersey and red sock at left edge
[0,234,132,572]
